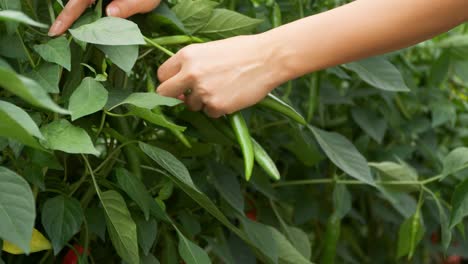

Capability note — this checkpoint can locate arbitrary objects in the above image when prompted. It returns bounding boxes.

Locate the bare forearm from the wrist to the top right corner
[262,0,468,81]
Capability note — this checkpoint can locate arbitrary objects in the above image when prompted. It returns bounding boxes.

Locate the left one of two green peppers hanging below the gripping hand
[228,112,255,181]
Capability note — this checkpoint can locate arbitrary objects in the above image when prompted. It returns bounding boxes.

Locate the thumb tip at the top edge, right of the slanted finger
[106,0,161,18]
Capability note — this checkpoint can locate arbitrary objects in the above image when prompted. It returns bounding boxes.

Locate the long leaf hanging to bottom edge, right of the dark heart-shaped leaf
[100,190,140,263]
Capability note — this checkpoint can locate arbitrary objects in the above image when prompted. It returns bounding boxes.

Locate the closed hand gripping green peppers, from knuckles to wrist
[157,35,287,118]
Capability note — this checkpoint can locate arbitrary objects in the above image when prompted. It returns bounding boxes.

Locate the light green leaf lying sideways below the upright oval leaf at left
[41,119,99,156]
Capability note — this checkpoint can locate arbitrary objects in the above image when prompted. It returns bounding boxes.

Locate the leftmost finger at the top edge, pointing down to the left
[49,0,94,37]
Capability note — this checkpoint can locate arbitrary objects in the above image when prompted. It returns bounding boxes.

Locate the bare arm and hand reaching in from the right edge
[52,0,468,118]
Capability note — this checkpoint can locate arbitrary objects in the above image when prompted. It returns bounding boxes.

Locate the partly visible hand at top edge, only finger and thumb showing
[49,0,161,37]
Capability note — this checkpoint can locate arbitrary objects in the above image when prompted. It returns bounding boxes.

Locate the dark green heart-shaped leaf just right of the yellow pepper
[41,195,84,255]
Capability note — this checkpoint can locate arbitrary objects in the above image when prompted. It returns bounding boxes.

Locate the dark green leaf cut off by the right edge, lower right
[450,179,468,228]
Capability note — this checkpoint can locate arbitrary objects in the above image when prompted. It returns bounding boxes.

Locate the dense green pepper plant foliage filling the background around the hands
[0,0,468,264]
